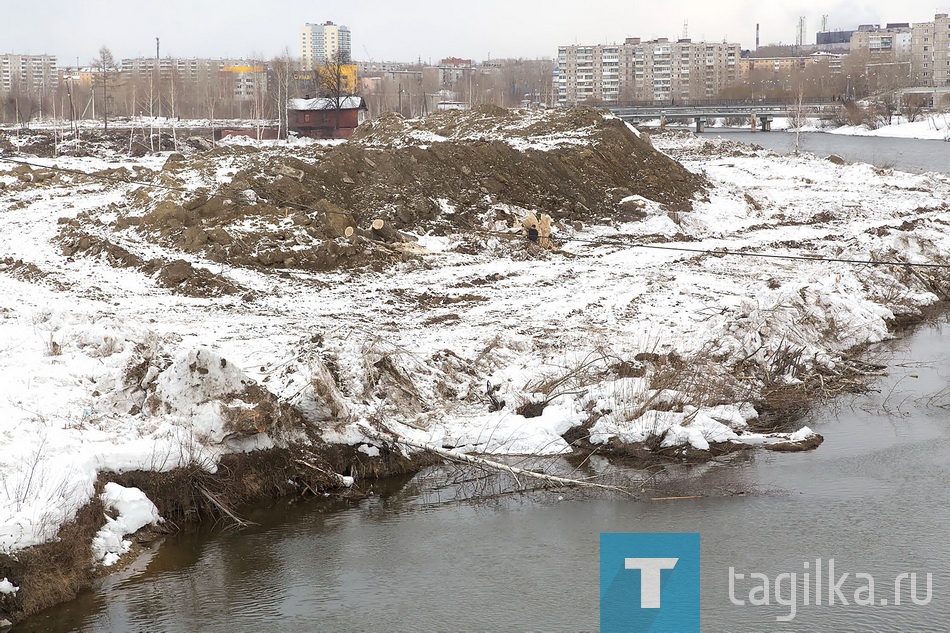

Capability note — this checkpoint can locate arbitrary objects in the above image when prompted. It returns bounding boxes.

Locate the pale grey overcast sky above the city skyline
[7,0,950,66]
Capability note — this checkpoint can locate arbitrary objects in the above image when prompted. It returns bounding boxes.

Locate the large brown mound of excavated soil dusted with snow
[46,107,706,278]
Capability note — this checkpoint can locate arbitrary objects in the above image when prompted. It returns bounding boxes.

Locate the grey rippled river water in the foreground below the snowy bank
[13,133,950,633]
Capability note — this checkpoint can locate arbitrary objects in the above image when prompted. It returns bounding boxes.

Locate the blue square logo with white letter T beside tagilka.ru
[600,534,700,633]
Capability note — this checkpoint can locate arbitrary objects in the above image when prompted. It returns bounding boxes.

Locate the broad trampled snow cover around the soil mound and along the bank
[0,119,950,556]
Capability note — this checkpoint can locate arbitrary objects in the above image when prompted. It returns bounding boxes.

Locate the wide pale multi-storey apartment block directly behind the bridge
[554,37,741,105]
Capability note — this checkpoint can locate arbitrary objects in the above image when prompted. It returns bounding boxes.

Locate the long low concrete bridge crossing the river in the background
[610,103,827,132]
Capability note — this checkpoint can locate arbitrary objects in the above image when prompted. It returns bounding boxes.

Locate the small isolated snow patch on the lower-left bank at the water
[92,482,162,567]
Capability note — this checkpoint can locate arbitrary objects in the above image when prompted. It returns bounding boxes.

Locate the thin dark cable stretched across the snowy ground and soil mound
[0,156,950,269]
